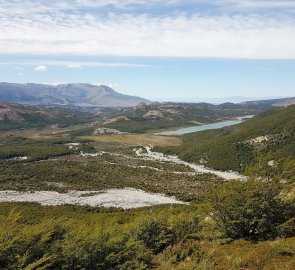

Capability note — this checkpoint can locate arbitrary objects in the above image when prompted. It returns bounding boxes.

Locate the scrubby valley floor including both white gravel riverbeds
[0,136,245,208]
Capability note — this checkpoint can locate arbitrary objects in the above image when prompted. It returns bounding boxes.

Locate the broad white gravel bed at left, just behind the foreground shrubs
[0,188,184,209]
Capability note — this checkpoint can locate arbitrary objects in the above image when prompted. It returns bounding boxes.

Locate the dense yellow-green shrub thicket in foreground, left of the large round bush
[0,203,198,270]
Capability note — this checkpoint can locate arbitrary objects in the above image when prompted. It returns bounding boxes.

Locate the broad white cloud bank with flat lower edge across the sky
[0,0,295,58]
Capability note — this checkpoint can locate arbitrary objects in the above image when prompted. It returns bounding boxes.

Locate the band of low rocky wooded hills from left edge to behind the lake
[0,99,261,135]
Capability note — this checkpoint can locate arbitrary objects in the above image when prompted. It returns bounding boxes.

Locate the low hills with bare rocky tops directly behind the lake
[101,103,262,133]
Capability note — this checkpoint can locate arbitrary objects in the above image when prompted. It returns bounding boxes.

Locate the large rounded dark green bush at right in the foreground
[207,180,295,241]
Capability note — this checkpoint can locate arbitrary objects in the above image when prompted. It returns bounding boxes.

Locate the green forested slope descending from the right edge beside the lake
[164,105,295,181]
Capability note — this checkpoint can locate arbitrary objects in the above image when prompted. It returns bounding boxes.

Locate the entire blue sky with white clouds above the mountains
[0,0,295,101]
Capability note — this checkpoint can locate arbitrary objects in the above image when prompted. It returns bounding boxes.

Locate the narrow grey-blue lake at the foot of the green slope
[156,115,253,136]
